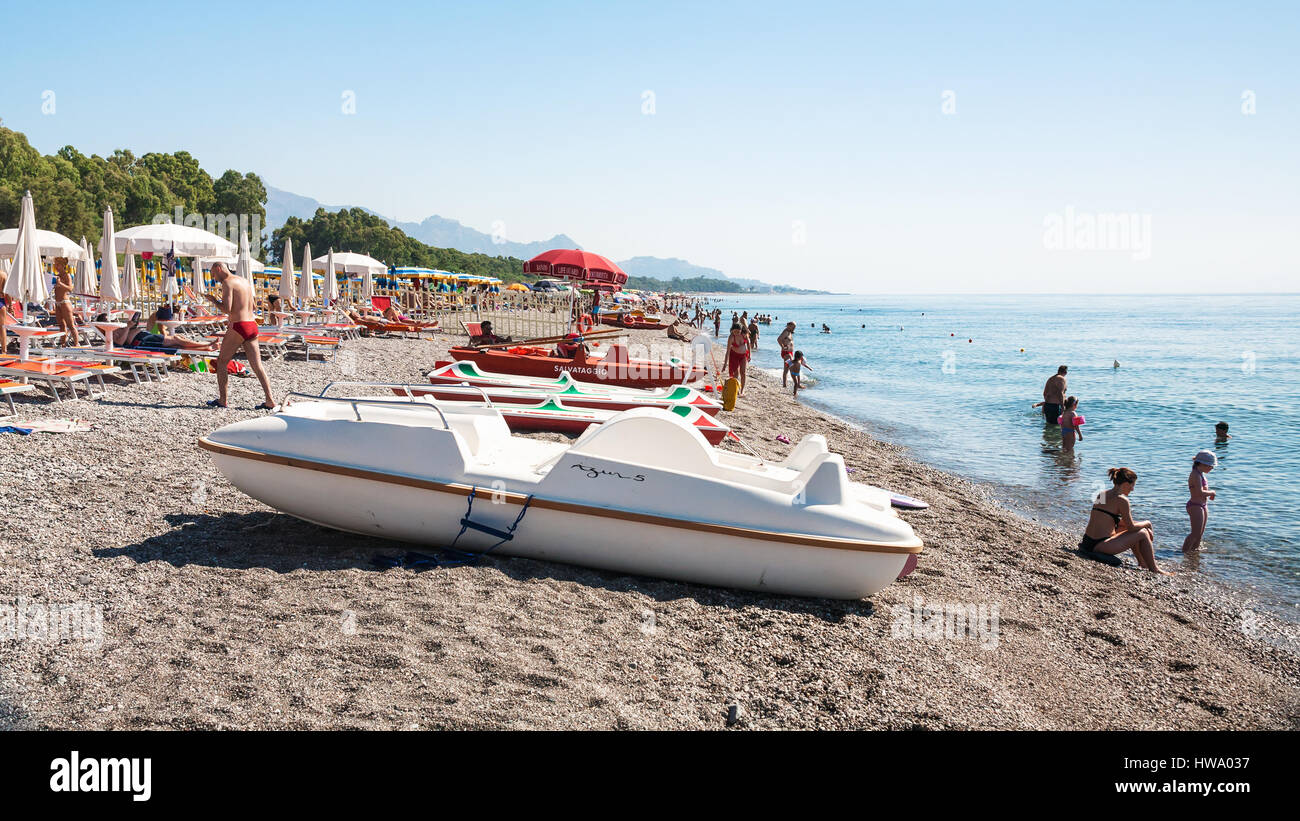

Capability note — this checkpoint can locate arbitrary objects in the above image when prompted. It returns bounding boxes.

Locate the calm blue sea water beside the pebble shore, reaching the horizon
[719,295,1300,618]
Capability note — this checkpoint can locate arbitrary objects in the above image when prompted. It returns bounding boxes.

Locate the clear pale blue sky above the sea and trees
[0,0,1300,294]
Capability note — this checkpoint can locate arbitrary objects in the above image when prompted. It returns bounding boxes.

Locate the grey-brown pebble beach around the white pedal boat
[0,323,1300,730]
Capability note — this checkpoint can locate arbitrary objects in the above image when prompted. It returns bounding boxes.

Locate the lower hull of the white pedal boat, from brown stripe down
[200,439,920,599]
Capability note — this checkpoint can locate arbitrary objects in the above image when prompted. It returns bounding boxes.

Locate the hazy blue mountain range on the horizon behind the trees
[267,186,811,291]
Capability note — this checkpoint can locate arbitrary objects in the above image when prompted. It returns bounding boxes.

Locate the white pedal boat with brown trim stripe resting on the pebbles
[200,396,922,599]
